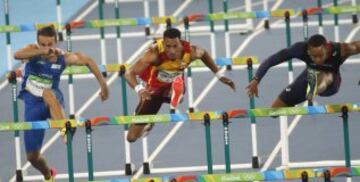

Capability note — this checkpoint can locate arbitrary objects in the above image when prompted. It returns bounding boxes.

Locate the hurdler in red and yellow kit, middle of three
[126,28,235,142]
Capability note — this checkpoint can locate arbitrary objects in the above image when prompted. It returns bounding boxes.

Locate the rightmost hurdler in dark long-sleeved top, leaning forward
[246,34,360,107]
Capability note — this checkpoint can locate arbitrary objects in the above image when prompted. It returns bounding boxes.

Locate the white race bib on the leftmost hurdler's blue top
[25,75,52,97]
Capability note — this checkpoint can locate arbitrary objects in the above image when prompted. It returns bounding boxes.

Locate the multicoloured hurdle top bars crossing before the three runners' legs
[0,102,360,131]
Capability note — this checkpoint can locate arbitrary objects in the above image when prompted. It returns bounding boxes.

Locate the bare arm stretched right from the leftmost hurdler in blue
[65,52,109,101]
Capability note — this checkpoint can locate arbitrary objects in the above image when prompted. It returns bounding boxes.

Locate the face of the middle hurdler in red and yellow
[164,37,182,60]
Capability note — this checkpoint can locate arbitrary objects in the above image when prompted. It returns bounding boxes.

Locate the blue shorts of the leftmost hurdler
[19,90,64,153]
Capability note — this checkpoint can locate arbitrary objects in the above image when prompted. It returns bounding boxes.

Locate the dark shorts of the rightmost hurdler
[279,69,341,106]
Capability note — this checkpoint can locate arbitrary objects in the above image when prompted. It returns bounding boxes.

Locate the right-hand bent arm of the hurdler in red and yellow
[191,46,236,91]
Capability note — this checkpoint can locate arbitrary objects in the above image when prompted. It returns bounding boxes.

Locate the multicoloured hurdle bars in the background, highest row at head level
[0,6,360,33]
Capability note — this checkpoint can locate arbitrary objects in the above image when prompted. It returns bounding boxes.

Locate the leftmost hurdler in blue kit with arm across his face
[15,26,109,181]
